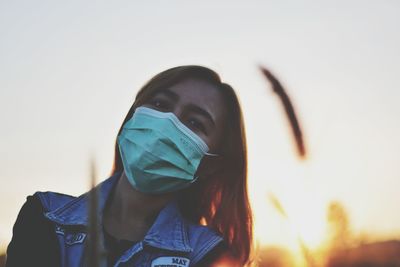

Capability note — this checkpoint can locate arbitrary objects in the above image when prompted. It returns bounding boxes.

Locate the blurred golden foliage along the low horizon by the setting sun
[257,202,400,267]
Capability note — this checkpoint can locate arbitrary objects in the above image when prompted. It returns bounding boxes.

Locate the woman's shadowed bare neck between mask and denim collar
[104,172,173,242]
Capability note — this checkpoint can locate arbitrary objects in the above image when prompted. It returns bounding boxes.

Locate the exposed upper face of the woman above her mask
[143,79,227,153]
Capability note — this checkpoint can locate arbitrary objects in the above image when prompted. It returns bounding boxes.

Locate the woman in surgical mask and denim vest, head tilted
[7,66,252,267]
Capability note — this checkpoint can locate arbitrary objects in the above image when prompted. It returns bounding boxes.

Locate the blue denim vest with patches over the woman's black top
[36,174,222,267]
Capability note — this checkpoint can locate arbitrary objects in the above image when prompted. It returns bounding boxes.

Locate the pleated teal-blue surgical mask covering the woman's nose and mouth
[117,107,216,194]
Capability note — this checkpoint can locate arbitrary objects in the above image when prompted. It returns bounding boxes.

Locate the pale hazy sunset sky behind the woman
[0,0,400,253]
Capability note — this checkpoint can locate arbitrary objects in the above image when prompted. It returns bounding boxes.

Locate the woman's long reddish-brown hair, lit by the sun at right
[112,65,253,264]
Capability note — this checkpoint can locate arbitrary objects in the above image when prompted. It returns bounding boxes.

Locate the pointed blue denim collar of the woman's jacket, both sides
[45,173,193,252]
